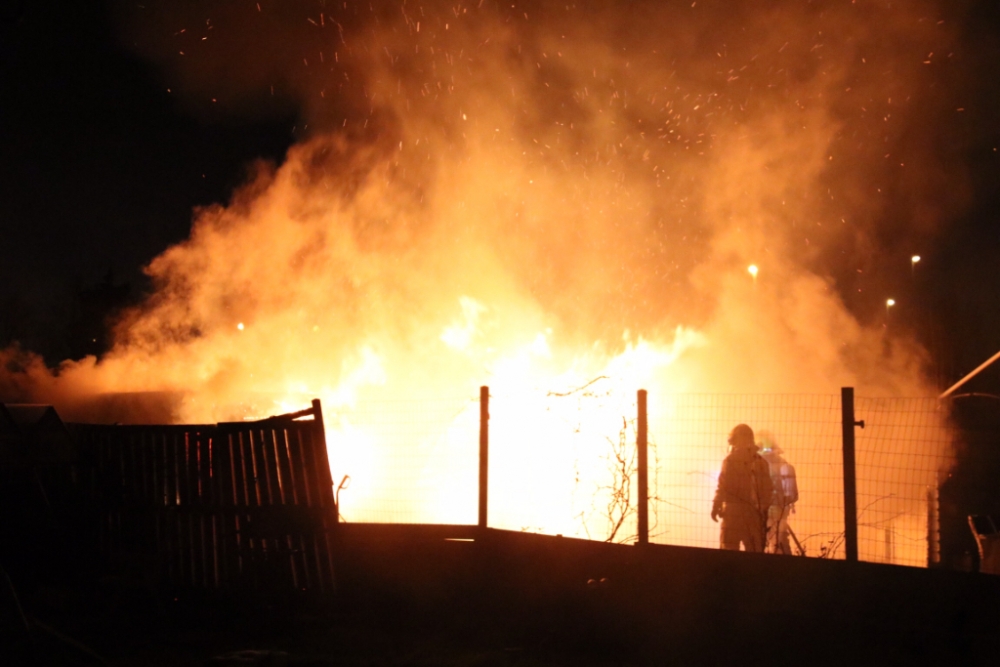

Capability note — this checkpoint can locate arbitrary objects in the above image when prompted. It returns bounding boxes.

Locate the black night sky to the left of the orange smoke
[0,1,296,362]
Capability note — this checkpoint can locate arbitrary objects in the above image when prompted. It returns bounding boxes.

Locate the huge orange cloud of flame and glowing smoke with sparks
[6,1,953,552]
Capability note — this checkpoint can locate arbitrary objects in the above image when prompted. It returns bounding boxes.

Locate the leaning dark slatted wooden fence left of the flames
[75,400,338,593]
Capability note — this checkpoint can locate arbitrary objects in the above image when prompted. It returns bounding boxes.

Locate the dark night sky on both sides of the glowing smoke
[0,0,1000,392]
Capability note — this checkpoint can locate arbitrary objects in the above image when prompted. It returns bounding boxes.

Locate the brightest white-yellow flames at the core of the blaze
[255,296,704,537]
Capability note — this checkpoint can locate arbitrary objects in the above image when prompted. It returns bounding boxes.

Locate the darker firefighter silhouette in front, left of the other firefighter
[712,424,773,552]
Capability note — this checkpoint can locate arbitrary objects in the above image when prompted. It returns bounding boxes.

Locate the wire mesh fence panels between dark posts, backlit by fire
[327,388,955,566]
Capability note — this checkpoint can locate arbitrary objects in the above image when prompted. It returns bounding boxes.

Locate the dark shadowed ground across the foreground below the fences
[4,526,1000,666]
